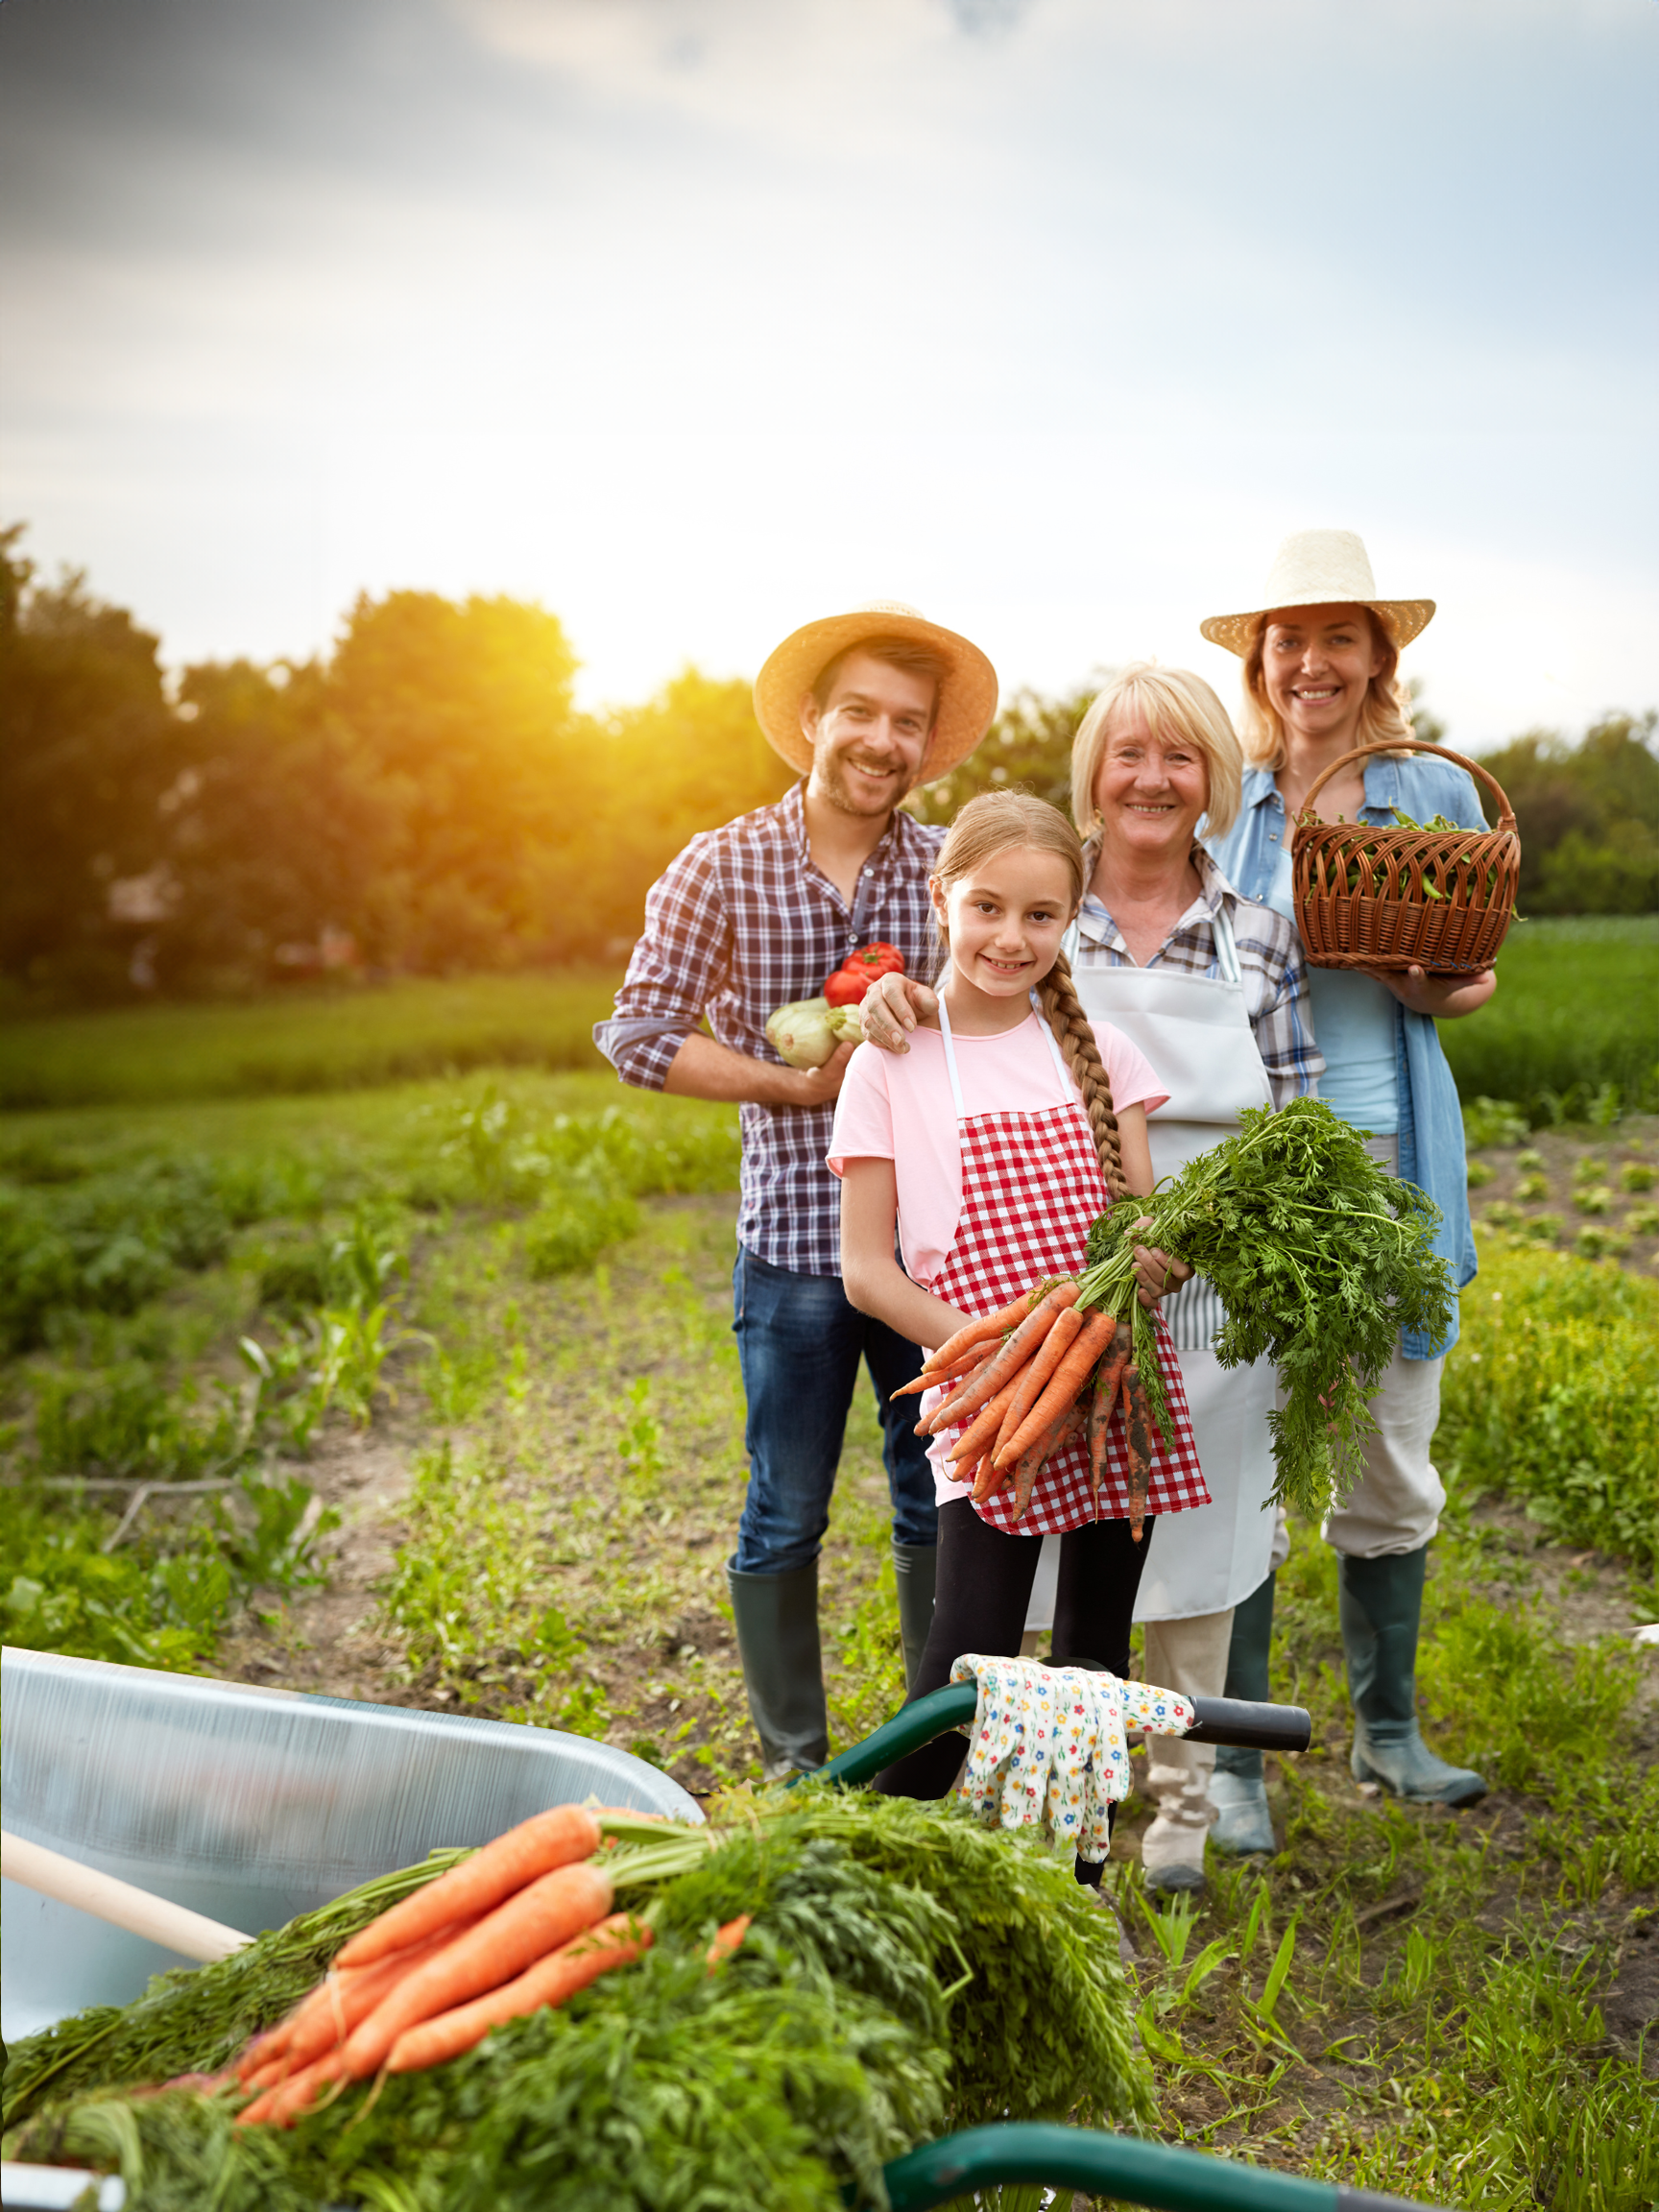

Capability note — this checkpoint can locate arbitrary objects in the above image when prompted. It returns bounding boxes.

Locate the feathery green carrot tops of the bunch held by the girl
[1077,1099,1454,1520]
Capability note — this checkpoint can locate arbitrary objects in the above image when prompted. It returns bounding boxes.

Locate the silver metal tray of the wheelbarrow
[0,1647,704,2044]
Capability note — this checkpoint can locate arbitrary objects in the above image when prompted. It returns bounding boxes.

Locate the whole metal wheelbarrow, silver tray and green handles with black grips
[0,1650,1411,2212]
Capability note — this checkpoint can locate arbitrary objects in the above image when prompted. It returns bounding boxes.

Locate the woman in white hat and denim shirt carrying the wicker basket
[1201,531,1498,1851]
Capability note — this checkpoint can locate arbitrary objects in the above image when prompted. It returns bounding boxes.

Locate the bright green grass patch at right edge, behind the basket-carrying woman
[1440,914,1659,1128]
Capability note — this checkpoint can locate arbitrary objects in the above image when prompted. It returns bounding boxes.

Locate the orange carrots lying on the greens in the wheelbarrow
[237,1805,748,2128]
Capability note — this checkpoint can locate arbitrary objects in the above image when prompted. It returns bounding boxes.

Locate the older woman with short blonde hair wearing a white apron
[865,661,1323,1889]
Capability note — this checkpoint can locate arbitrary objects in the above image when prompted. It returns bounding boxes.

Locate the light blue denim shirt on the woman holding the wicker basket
[1203,755,1486,1360]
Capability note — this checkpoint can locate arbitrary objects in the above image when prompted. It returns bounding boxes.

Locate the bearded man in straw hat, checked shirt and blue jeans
[592,602,998,1778]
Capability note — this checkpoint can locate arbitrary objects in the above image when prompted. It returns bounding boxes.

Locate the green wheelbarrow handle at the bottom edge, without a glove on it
[882,2119,1425,2212]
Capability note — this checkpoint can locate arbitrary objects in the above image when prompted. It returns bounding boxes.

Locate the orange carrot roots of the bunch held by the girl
[894,1281,1152,1544]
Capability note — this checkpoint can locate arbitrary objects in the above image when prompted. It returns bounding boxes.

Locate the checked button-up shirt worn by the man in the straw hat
[592,783,945,1274]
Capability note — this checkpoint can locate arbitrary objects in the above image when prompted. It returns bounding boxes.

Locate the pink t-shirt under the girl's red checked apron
[830,1013,1168,1286]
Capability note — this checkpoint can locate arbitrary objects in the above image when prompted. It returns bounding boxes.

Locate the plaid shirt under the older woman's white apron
[1077,845,1325,1106]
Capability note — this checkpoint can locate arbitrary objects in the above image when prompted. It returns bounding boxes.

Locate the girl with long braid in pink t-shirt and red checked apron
[830,792,1210,1814]
